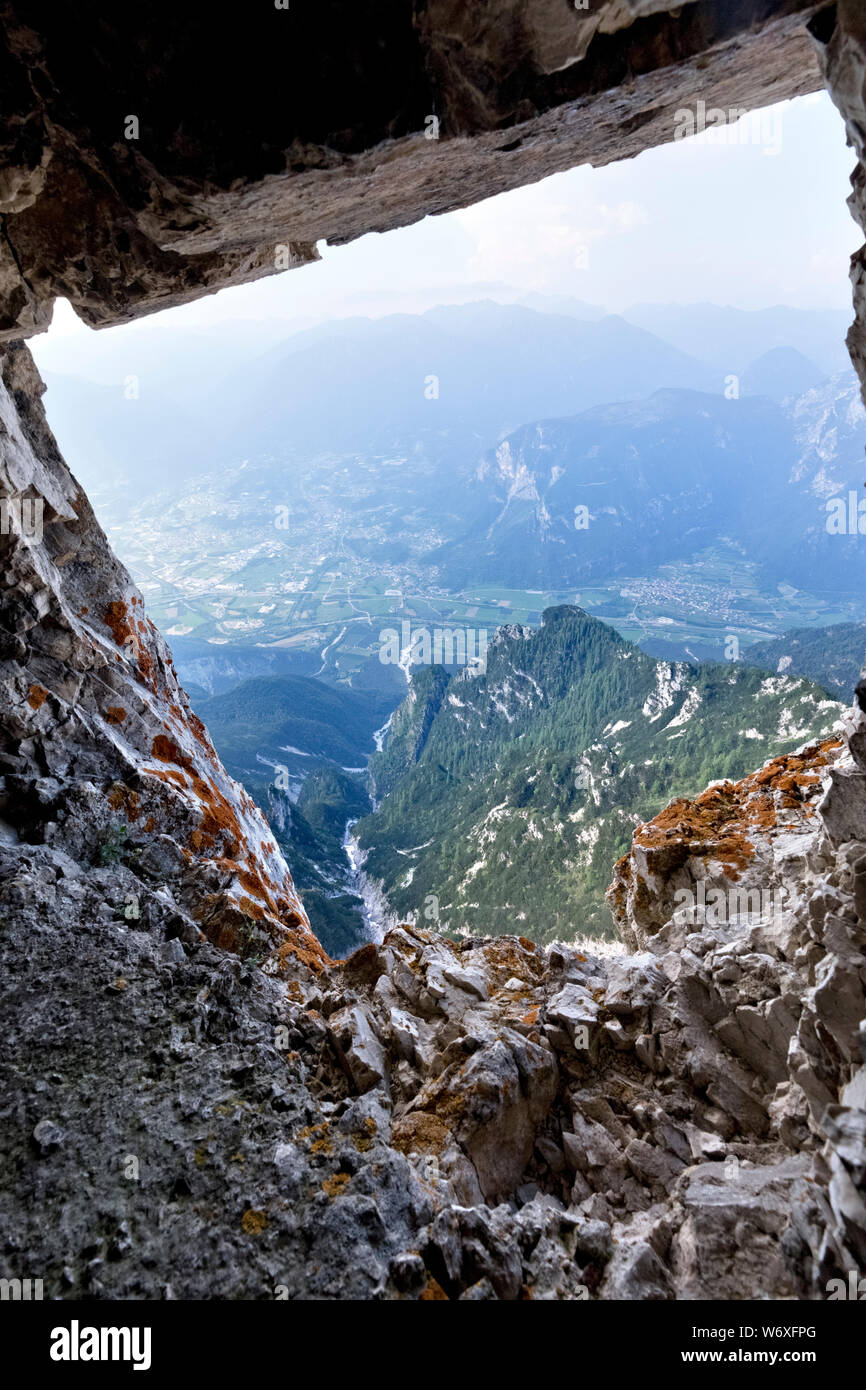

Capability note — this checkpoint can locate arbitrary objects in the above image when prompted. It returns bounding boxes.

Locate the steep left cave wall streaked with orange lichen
[0,343,324,966]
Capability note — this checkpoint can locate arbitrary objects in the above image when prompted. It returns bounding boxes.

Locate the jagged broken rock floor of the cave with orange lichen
[0,708,866,1300]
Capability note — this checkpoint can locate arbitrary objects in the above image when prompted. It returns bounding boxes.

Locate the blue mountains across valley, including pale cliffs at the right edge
[430,375,866,589]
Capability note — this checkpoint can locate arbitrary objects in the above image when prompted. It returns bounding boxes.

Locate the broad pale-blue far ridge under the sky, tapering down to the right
[35,302,721,496]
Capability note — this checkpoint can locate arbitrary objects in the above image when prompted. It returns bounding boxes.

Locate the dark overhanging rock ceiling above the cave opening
[0,0,851,339]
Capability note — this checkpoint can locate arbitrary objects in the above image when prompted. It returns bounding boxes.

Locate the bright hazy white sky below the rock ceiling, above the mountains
[40,93,862,353]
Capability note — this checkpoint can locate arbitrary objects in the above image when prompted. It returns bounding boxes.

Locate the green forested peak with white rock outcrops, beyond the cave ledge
[357,606,840,941]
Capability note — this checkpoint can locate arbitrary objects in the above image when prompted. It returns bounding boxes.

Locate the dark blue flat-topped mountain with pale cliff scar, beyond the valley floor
[431,391,795,588]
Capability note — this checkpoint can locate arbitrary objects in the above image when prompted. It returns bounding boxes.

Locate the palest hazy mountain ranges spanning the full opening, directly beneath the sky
[36,295,847,498]
